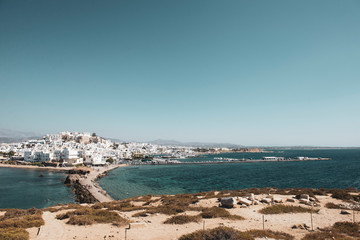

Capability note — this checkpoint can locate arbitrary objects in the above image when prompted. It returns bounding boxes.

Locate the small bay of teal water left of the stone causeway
[0,168,75,209]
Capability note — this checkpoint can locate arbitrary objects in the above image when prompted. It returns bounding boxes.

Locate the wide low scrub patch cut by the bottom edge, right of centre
[179,227,294,240]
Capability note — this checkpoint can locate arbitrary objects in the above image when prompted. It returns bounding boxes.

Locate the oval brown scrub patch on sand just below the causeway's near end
[56,208,129,226]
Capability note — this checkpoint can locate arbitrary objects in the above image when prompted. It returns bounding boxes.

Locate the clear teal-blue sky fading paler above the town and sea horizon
[0,0,360,146]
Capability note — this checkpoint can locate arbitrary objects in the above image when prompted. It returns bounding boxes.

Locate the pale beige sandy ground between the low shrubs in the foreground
[7,195,354,240]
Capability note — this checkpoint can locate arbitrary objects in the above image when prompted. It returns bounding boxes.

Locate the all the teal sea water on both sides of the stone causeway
[0,149,360,208]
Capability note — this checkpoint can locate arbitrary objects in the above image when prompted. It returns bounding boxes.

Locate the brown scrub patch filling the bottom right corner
[302,222,360,240]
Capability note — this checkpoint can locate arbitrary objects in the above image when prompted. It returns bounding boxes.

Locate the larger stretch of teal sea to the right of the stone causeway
[99,149,360,199]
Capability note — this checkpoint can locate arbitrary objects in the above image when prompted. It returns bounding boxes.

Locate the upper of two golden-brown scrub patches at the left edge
[0,208,45,228]
